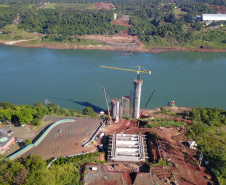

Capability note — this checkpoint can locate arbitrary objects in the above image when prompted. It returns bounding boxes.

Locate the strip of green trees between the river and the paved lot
[0,102,97,125]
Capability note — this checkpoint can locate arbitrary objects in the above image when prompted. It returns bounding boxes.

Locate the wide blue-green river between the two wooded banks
[0,46,226,111]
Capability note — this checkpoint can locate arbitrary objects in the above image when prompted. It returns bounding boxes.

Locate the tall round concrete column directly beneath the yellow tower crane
[133,79,143,119]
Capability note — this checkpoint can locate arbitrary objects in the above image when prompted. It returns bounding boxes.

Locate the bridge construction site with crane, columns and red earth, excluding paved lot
[83,66,216,185]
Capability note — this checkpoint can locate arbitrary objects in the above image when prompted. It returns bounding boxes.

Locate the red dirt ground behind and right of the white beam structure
[102,112,214,185]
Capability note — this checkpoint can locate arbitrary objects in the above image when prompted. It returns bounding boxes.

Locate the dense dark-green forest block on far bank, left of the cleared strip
[19,9,113,35]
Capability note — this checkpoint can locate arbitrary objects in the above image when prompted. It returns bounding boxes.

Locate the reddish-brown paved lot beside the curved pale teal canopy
[22,118,102,159]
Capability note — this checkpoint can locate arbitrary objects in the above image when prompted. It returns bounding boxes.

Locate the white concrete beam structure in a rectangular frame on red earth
[108,134,148,162]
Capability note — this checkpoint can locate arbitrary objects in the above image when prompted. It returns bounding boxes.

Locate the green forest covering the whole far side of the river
[0,0,226,48]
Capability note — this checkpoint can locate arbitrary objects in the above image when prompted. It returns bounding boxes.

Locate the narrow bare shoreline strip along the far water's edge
[0,40,226,53]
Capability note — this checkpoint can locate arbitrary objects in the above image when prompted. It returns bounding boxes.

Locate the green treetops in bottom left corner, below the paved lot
[0,152,102,185]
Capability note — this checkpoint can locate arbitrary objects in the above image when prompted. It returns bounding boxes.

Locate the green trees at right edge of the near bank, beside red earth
[187,108,226,184]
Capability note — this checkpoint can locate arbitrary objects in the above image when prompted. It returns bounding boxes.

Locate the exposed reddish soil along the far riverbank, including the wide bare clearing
[0,33,226,53]
